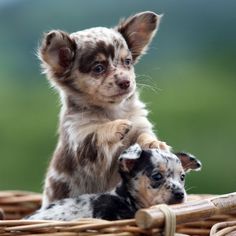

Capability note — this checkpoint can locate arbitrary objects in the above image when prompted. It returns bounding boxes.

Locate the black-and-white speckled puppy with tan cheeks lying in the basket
[28,144,201,221]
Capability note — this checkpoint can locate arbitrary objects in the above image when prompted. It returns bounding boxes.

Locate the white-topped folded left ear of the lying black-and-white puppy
[119,143,142,172]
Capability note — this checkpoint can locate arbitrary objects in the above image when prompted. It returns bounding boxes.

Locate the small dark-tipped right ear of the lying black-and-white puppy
[175,152,202,172]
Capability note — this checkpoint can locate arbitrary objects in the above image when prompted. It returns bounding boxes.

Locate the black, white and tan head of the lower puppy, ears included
[119,144,201,207]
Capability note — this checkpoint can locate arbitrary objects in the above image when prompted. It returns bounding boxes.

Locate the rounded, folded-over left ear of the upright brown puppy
[38,30,76,76]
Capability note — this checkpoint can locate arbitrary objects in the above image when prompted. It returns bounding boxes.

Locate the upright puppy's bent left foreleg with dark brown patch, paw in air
[77,119,132,175]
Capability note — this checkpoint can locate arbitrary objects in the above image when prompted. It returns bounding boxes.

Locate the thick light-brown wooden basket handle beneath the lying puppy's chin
[135,192,236,229]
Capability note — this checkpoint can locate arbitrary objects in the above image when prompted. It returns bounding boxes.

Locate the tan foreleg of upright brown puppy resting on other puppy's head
[137,133,171,151]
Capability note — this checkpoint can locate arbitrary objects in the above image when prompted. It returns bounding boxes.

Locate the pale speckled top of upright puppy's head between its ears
[70,27,128,49]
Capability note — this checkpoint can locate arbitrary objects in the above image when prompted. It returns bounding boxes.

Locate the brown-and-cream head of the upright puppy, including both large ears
[39,12,160,105]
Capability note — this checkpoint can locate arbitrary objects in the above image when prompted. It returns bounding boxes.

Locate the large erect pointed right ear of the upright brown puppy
[116,11,161,62]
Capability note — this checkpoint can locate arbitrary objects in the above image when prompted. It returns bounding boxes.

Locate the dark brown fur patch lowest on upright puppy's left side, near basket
[49,177,70,201]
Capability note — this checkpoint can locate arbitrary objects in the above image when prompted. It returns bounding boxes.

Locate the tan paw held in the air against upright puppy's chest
[113,119,132,142]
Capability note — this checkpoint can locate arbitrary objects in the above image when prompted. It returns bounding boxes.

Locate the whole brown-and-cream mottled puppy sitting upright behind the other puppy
[39,12,169,207]
